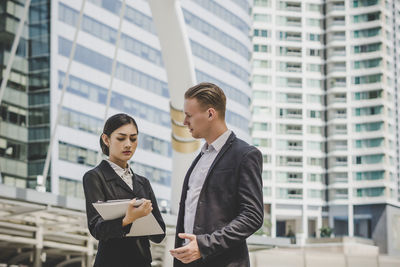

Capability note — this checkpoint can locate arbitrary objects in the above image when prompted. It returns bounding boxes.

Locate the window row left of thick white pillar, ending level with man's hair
[58,37,169,97]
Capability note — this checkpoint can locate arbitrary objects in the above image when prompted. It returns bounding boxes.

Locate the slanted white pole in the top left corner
[0,0,31,183]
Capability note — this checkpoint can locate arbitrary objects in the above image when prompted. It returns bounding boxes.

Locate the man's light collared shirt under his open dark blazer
[184,130,231,237]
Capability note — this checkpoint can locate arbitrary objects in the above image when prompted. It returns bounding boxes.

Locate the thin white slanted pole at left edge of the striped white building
[42,0,86,186]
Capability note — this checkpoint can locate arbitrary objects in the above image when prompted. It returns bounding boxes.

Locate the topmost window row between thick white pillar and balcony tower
[191,0,250,36]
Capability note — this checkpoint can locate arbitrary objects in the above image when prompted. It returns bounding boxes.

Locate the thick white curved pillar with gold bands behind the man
[149,0,200,215]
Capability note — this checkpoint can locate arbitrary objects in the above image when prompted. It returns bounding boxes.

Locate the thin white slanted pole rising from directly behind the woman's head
[97,0,126,162]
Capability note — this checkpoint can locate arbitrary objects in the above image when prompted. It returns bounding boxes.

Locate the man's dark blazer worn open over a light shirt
[174,133,264,267]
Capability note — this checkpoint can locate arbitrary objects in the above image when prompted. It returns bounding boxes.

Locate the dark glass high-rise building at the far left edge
[0,1,50,193]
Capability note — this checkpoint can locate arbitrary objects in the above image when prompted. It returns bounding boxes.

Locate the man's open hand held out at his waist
[169,234,201,263]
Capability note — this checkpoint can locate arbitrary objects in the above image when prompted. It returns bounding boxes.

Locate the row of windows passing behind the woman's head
[60,108,172,157]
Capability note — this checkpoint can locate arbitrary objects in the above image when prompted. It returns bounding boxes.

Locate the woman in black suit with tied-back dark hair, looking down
[83,114,165,267]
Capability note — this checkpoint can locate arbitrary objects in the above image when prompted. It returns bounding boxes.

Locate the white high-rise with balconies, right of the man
[252,0,400,253]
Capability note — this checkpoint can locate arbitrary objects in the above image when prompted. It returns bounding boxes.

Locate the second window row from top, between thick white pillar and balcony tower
[190,41,249,81]
